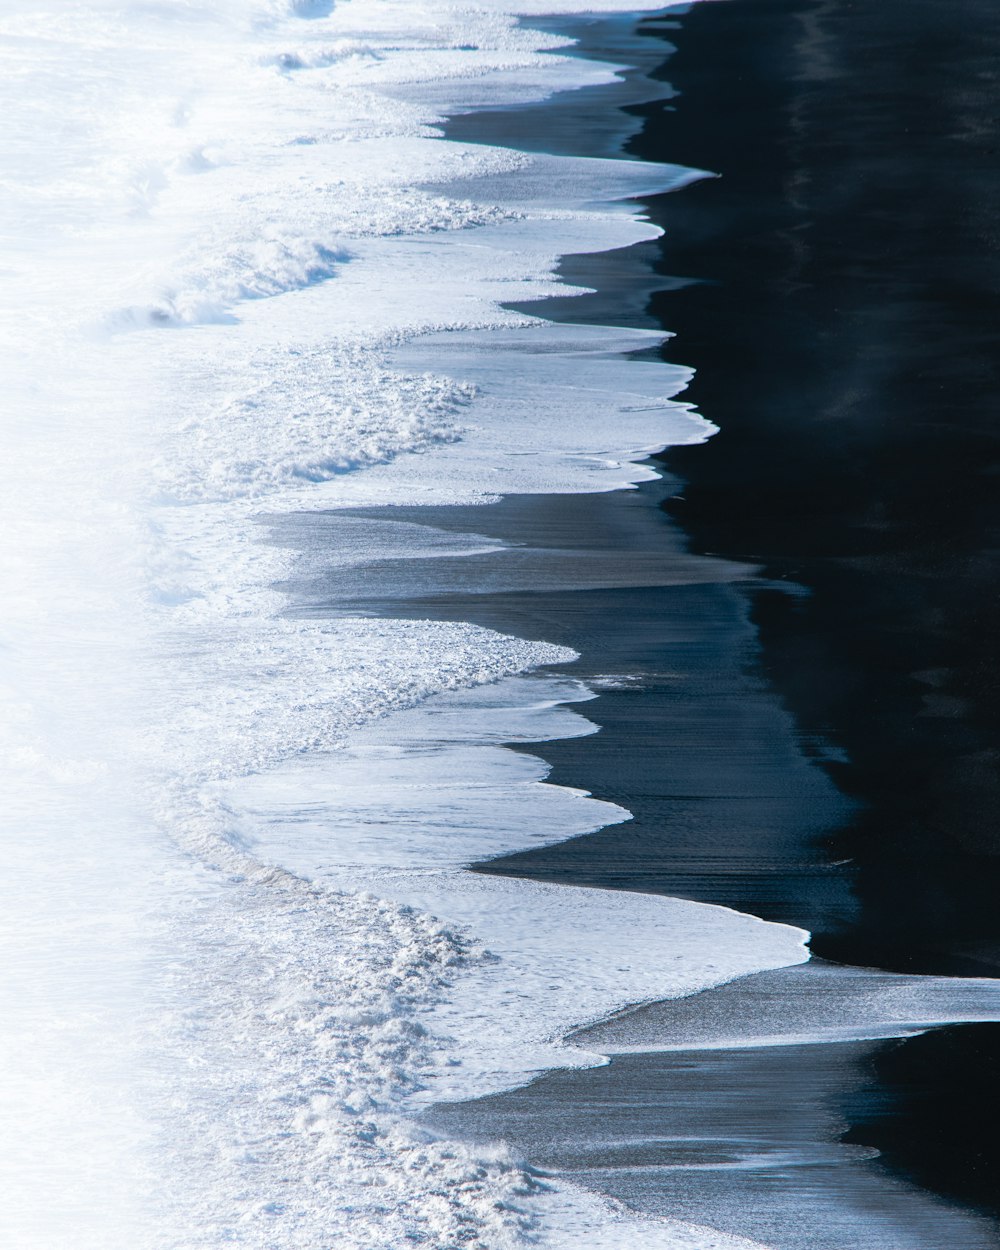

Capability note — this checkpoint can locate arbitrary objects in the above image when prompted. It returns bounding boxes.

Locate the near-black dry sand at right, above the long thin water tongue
[633,0,1000,975]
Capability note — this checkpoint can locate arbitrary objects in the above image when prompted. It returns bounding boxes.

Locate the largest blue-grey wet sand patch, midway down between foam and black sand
[291,483,855,929]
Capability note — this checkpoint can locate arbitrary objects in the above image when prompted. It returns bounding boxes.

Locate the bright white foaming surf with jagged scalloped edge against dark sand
[0,0,808,1250]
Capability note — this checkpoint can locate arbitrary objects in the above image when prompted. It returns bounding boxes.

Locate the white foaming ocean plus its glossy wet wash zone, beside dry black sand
[0,0,1000,1250]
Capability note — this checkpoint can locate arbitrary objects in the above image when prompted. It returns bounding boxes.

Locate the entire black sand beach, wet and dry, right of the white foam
[287,0,1000,1250]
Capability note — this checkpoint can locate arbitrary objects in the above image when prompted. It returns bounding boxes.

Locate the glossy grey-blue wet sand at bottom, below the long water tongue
[433,1039,1000,1250]
